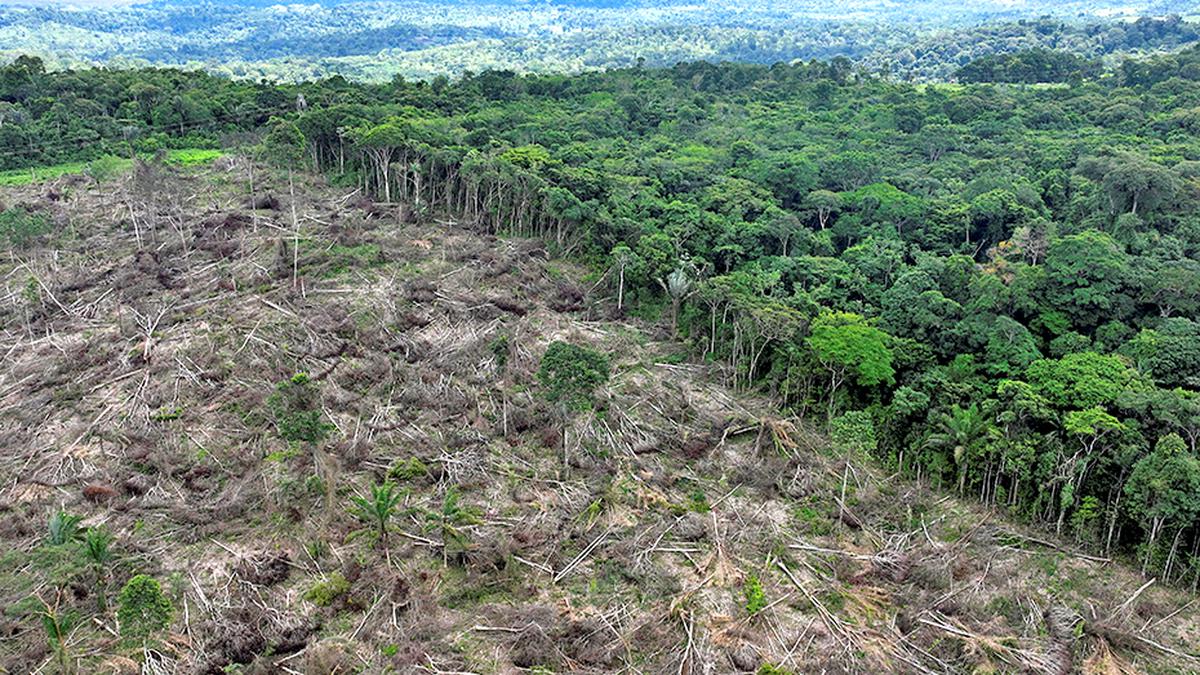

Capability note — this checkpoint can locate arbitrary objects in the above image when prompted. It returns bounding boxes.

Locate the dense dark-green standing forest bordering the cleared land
[7,43,1200,587]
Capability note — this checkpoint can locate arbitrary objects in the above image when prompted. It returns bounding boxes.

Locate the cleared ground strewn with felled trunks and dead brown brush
[0,162,1200,674]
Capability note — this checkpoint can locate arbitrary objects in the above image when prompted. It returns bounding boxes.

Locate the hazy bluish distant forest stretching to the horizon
[0,0,1200,82]
